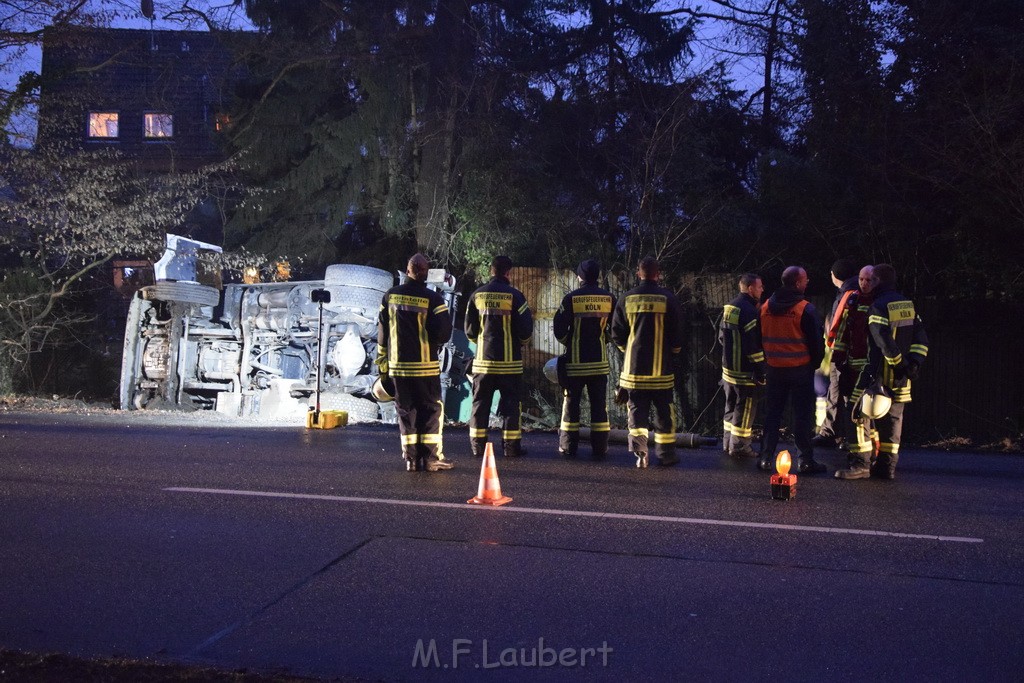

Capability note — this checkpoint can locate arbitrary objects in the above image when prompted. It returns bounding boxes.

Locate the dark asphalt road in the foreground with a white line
[0,413,1024,681]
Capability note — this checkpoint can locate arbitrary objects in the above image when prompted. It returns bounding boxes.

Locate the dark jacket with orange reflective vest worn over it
[761,287,824,368]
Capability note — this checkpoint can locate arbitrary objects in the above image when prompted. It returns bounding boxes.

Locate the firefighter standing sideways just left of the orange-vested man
[718,272,765,458]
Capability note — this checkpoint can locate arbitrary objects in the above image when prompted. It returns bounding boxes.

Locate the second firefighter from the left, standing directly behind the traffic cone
[465,256,534,458]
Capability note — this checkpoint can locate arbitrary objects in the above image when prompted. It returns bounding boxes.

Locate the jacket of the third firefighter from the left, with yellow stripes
[554,283,615,377]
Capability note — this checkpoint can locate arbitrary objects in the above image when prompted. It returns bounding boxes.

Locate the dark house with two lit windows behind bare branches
[39,27,253,172]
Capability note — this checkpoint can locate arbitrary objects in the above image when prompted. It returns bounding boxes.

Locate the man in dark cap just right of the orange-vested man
[814,258,858,449]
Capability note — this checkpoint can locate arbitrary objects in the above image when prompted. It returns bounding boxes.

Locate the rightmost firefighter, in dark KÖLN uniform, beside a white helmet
[836,263,928,479]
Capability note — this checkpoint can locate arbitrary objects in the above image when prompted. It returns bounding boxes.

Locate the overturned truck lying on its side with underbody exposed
[121,236,468,422]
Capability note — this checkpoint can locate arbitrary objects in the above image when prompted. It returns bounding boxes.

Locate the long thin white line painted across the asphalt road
[164,486,984,543]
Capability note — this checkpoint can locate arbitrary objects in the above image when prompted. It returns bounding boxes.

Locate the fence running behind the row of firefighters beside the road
[510,268,1024,443]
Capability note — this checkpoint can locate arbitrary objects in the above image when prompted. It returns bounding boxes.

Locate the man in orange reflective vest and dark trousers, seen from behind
[758,265,825,474]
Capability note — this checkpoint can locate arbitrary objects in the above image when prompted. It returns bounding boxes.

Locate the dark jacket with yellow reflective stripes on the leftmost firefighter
[377,280,452,377]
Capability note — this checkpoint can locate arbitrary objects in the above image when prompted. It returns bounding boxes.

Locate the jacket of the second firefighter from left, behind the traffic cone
[466,276,534,375]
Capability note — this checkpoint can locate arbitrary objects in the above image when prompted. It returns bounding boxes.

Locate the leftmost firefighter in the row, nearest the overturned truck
[377,254,454,472]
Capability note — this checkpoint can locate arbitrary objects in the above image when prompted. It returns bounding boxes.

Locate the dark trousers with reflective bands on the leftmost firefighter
[393,375,444,461]
